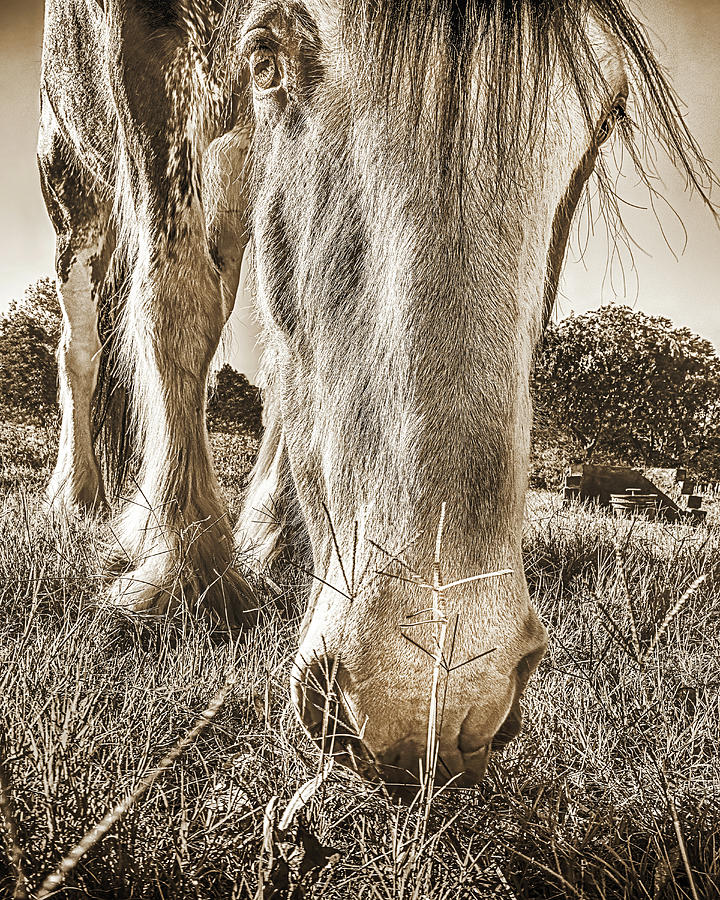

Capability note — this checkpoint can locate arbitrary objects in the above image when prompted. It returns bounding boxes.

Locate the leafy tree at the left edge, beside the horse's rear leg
[0,278,61,422]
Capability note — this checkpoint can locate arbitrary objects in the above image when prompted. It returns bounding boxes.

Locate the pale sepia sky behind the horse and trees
[0,0,720,378]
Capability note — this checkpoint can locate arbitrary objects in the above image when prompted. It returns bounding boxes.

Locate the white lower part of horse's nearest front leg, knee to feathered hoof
[114,203,255,628]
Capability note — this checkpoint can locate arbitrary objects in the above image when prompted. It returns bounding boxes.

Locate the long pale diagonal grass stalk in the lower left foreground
[37,675,236,900]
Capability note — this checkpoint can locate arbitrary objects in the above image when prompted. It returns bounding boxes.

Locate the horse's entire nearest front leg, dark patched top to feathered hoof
[102,2,256,628]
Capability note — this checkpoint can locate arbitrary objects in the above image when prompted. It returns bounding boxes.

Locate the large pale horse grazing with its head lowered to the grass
[38,0,713,783]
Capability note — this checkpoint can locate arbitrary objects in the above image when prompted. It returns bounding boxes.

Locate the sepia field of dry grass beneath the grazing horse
[0,426,720,900]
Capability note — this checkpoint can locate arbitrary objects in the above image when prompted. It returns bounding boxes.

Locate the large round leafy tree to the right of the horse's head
[532,305,720,474]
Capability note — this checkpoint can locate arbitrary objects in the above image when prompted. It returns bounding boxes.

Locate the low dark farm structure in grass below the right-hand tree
[563,463,707,524]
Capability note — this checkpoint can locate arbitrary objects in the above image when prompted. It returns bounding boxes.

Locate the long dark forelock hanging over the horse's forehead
[340,0,716,205]
